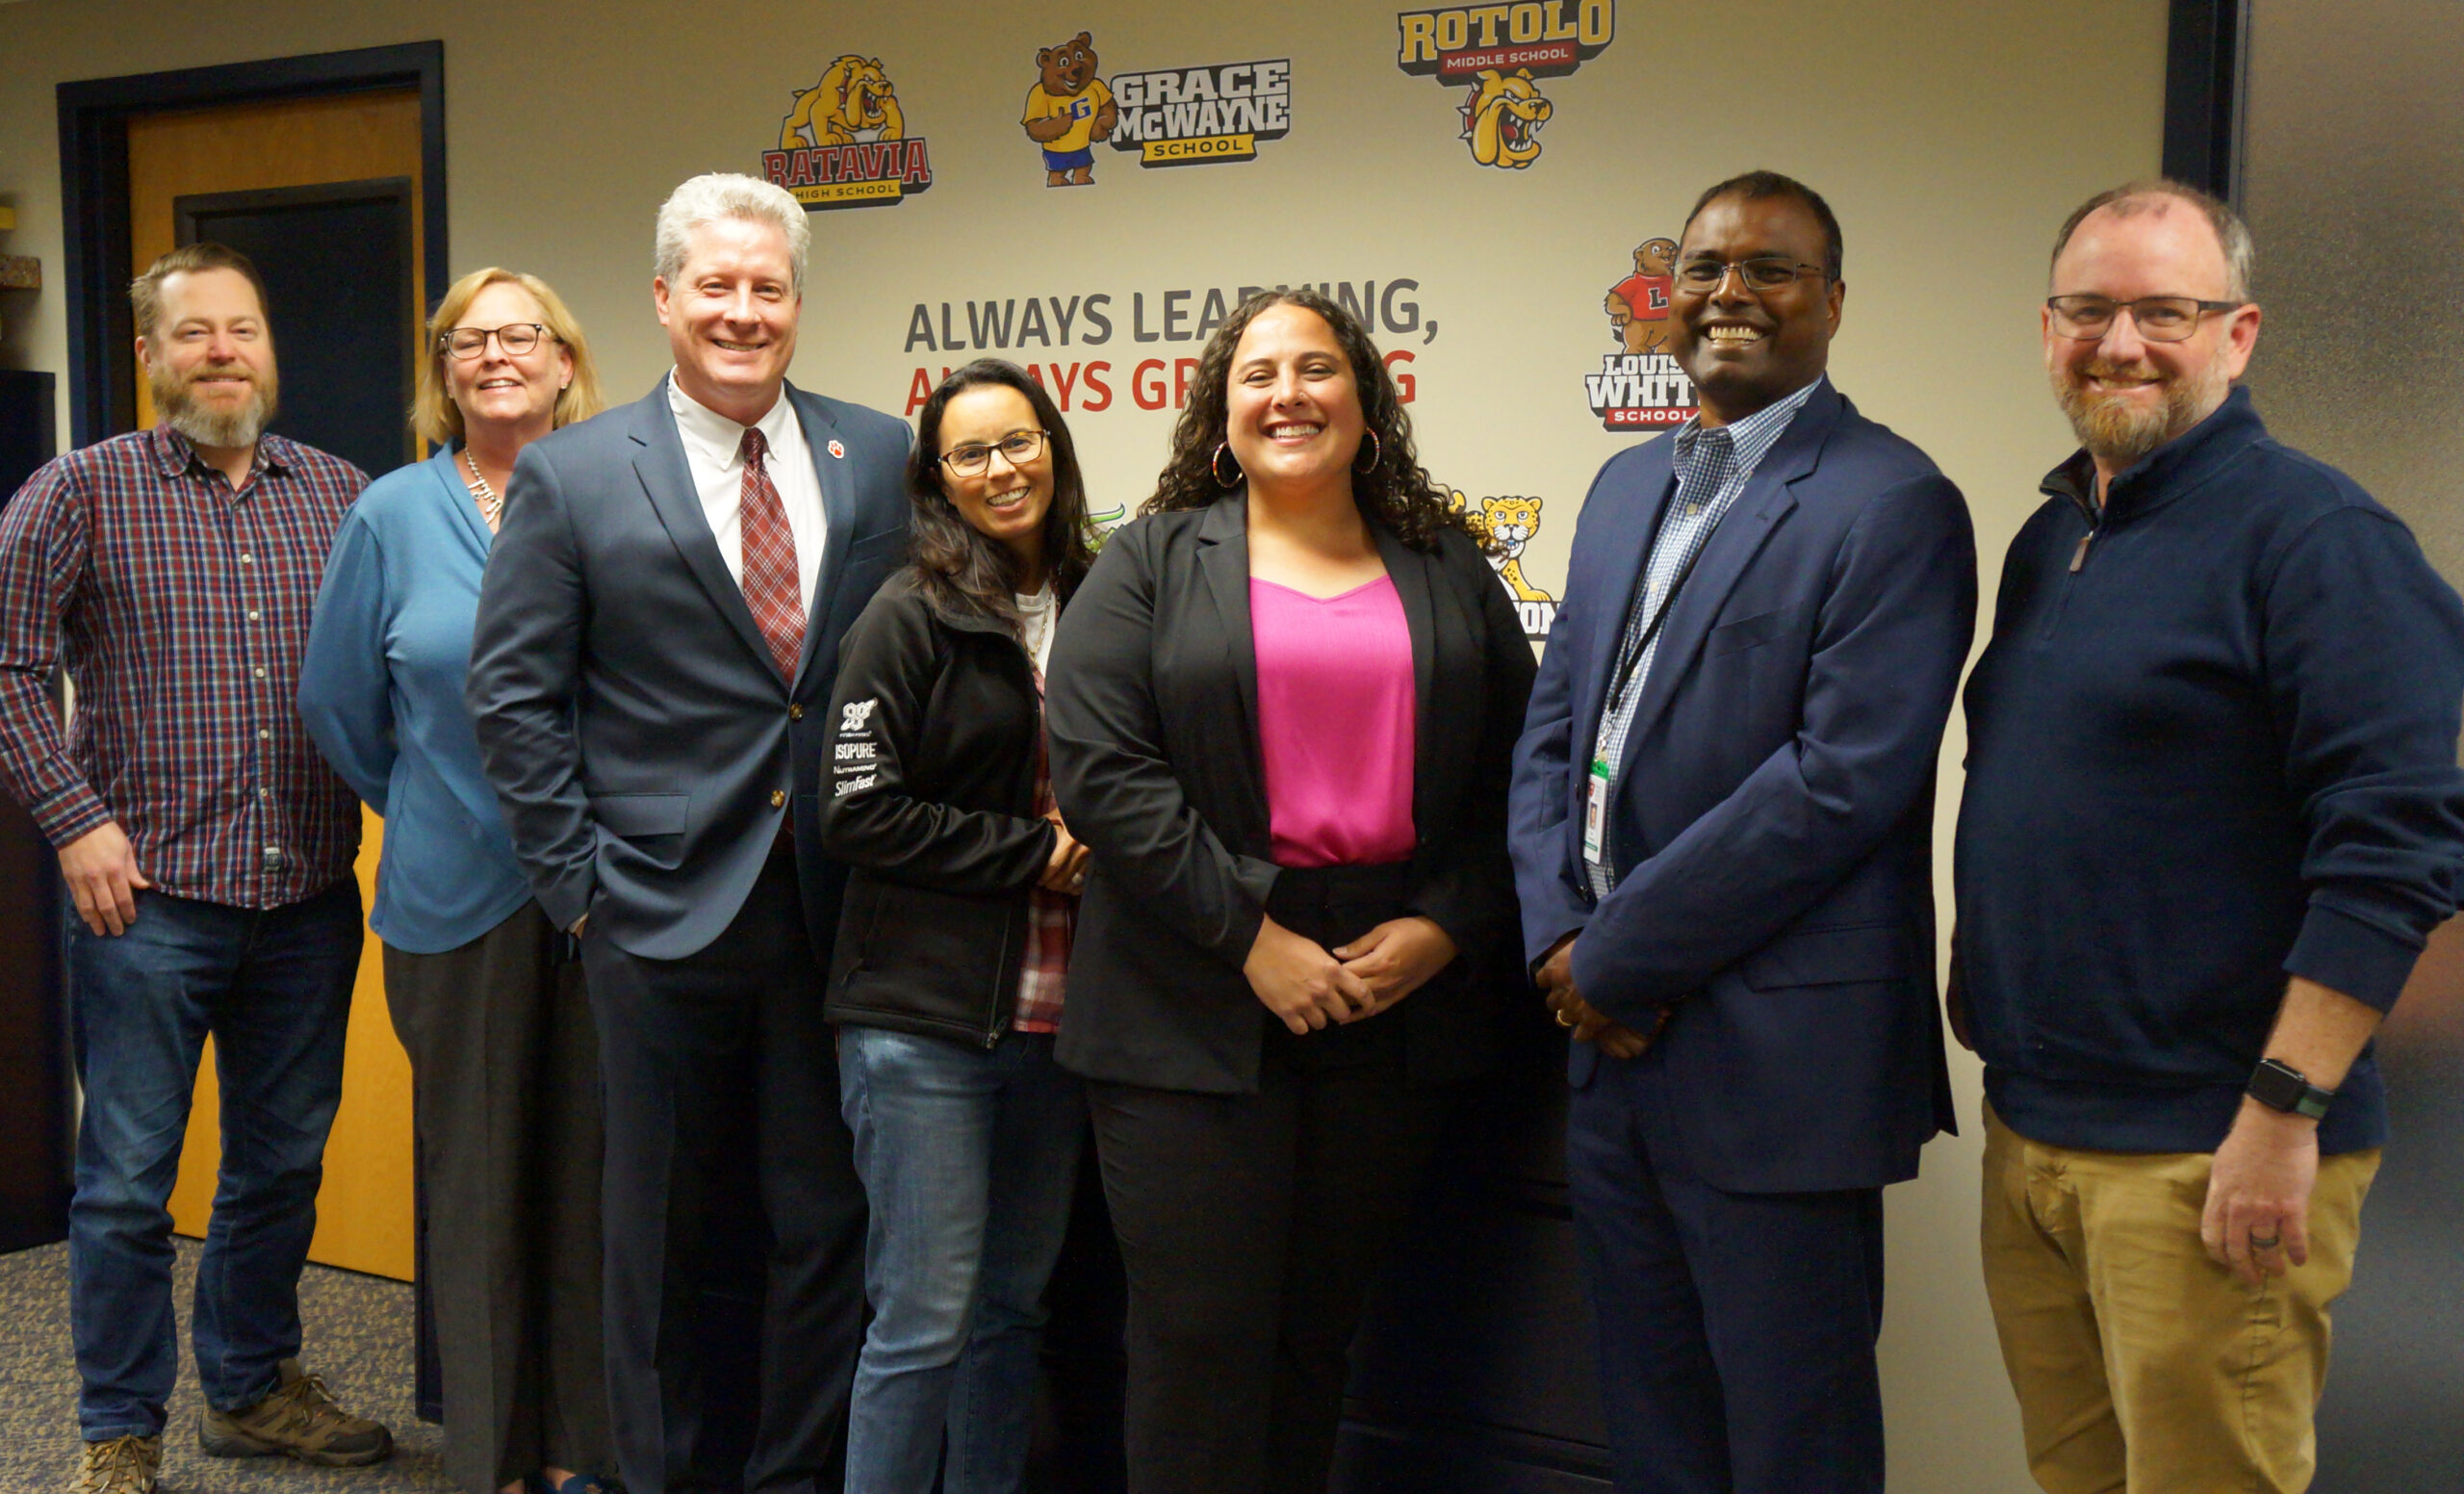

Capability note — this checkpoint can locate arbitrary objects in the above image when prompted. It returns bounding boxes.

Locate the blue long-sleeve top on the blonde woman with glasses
[298,449,529,954]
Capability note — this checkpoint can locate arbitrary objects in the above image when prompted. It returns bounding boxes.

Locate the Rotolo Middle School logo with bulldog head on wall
[1395,0,1616,170]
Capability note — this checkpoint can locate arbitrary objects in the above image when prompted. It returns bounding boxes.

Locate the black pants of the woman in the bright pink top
[1087,867,1459,1494]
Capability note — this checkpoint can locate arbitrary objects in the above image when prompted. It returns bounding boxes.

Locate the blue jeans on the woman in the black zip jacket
[837,1028,1087,1494]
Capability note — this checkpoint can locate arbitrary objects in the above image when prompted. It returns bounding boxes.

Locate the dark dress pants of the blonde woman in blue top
[384,902,616,1494]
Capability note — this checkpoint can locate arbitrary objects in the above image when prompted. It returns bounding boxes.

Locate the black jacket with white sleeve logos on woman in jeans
[815,570,1055,1047]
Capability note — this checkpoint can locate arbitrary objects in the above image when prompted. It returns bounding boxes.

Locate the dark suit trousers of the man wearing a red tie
[581,853,865,1494]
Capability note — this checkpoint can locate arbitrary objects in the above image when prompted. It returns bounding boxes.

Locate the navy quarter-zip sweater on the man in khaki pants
[1957,390,2464,1154]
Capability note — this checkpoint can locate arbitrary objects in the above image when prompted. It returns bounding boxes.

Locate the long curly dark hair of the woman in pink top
[1139,286,1496,553]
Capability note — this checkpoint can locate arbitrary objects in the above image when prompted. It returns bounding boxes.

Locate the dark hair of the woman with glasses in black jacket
[907,357,1094,627]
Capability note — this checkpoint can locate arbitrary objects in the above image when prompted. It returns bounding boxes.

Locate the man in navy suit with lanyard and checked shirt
[1510,172,1976,1494]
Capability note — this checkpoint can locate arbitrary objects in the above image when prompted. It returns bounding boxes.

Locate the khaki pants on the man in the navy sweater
[1984,1107,2377,1494]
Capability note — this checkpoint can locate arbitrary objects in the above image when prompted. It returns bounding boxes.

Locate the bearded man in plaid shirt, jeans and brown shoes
[0,245,392,1494]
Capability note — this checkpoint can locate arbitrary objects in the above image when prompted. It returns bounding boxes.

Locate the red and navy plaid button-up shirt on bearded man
[0,426,367,907]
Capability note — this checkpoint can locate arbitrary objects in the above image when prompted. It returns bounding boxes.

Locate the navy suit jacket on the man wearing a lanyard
[1510,382,1976,1194]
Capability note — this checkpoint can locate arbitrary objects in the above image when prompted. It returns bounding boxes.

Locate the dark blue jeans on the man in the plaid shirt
[69,878,360,1442]
